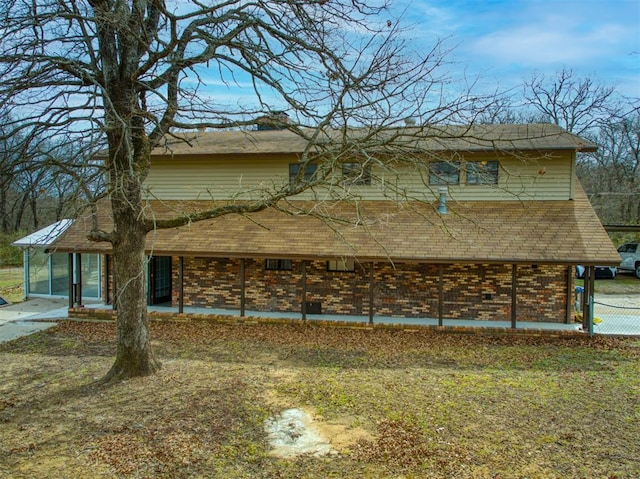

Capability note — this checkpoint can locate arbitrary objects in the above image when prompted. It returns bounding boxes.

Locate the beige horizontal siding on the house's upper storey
[146,151,574,201]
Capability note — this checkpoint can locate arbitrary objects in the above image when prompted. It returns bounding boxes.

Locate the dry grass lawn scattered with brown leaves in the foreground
[0,322,640,479]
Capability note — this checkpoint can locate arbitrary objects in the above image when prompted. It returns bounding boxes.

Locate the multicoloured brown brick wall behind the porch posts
[166,257,567,322]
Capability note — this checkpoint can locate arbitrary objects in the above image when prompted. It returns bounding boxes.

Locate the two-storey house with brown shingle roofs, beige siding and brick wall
[28,124,619,324]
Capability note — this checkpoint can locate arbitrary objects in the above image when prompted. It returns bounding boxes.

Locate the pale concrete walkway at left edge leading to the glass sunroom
[0,298,68,343]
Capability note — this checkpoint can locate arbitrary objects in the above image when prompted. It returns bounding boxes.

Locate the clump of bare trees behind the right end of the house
[516,68,640,231]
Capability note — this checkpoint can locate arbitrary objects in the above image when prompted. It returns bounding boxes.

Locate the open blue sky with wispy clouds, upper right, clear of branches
[396,0,640,98]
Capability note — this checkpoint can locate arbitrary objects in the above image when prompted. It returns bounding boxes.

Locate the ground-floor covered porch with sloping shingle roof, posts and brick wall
[52,186,618,336]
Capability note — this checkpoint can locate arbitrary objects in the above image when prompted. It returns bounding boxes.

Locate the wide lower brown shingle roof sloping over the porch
[57,184,619,265]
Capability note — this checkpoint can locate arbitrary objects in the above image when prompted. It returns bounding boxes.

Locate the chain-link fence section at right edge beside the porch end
[593,297,640,336]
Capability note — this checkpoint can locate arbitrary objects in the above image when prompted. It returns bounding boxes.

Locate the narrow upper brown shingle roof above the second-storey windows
[152,123,596,156]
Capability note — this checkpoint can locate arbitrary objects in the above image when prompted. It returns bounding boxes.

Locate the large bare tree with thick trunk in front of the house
[0,0,490,381]
